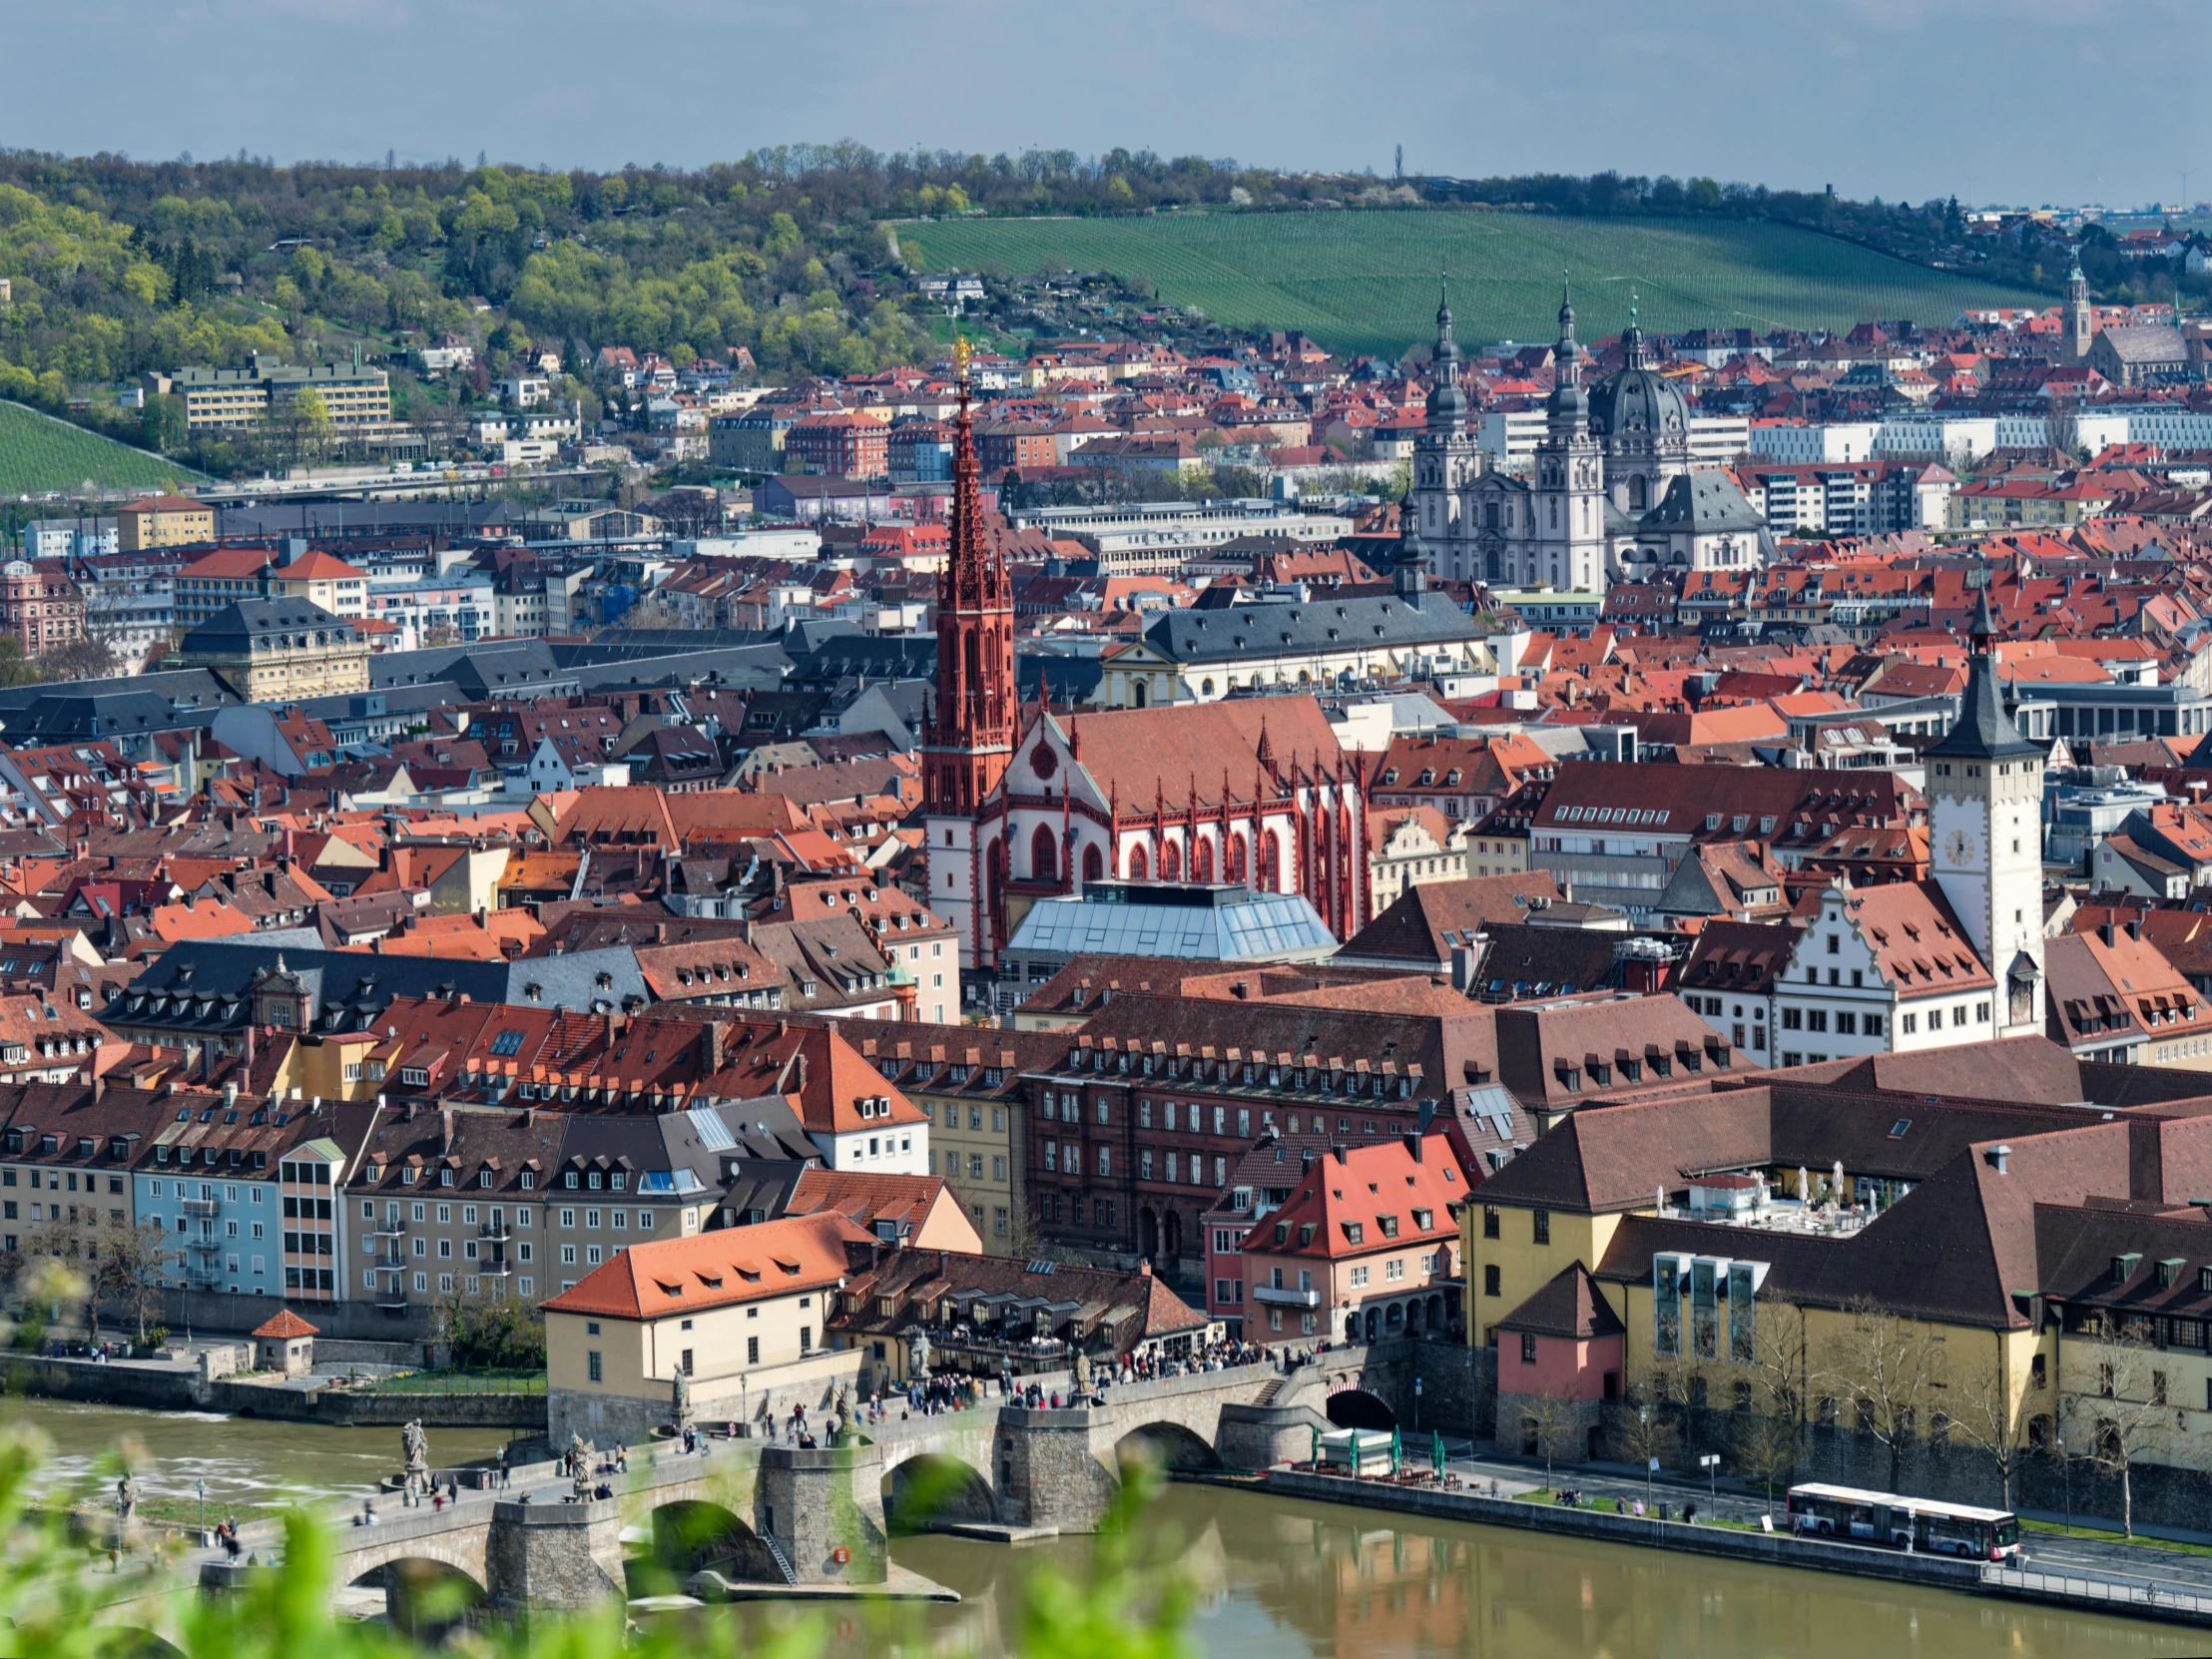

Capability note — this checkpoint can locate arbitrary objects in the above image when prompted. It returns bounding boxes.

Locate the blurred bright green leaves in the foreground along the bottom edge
[0,1429,1197,1659]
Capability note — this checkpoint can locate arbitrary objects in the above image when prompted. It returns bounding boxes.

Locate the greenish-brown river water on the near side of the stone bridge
[715,1486,2208,1659]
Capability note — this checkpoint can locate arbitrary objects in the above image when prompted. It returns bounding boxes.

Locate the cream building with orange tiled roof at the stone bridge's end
[544,1215,871,1444]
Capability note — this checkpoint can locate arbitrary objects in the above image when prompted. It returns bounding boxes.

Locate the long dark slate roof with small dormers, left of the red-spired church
[100,940,651,1033]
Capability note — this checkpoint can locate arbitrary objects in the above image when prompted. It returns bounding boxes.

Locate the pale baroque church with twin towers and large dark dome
[1411,282,1774,593]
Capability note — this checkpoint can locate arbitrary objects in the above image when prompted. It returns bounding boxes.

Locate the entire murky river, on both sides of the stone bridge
[0,1398,2212,1659]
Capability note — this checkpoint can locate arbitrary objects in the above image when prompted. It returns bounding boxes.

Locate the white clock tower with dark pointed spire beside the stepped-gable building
[1925,588,2044,1037]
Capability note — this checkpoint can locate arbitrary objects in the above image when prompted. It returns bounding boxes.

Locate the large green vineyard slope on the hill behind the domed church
[898,211,2052,354]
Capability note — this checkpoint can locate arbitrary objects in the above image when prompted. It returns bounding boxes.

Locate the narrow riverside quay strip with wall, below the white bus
[1261,1468,2212,1628]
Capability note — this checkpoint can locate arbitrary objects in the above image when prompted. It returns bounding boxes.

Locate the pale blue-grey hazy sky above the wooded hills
[0,0,2212,208]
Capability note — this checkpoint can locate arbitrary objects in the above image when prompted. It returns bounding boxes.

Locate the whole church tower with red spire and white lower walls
[920,338,1020,969]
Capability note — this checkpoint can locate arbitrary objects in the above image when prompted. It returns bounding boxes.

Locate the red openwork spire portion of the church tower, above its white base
[922,338,1020,814]
